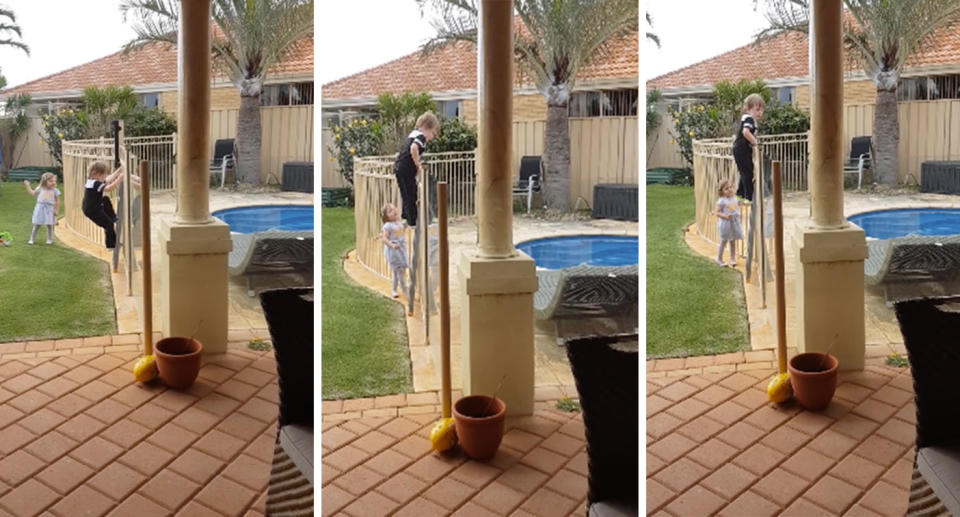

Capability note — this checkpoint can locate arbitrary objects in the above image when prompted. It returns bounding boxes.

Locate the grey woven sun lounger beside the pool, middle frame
[533,265,639,340]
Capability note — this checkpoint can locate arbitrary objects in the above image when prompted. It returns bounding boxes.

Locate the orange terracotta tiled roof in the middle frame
[323,33,639,100]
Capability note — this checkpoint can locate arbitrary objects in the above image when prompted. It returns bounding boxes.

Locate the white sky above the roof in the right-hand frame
[640,0,767,79]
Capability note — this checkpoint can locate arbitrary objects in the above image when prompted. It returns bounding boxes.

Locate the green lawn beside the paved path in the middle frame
[320,208,413,399]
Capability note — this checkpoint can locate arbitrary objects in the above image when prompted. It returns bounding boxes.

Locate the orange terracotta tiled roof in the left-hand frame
[2,38,313,95]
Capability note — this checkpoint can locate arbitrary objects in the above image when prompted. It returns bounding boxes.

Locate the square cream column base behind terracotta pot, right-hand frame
[794,221,867,370]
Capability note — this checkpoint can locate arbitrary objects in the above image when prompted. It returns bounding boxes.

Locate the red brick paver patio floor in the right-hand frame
[646,351,916,517]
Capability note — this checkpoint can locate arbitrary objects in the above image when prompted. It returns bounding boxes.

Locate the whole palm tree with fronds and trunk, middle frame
[417,0,639,211]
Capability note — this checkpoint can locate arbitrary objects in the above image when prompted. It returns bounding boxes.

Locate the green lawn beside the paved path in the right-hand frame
[647,185,750,358]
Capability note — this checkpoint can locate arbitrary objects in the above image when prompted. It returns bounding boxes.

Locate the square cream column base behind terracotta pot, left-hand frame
[160,218,232,354]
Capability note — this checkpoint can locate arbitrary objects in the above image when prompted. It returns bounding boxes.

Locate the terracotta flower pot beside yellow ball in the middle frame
[453,395,507,460]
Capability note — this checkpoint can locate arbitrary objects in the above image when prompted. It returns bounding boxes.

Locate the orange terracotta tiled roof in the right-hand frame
[647,22,960,88]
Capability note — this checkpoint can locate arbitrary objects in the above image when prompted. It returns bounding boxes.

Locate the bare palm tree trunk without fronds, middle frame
[543,103,570,212]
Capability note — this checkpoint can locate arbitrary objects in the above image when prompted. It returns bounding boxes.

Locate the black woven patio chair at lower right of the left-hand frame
[260,288,314,515]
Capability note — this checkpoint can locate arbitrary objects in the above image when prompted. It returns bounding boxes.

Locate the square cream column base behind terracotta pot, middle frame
[460,250,537,415]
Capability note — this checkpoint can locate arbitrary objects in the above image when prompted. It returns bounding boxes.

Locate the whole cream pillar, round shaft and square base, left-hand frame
[160,0,232,353]
